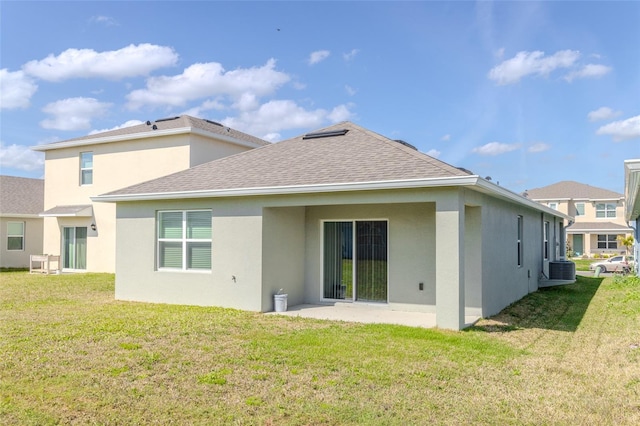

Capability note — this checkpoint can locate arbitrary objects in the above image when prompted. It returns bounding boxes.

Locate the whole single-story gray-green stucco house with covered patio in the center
[92,122,567,329]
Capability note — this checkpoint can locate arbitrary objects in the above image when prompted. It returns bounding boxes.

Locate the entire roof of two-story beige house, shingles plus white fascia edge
[31,115,270,151]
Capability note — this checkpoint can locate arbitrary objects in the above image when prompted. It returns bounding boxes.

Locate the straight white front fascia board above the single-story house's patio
[91,176,478,202]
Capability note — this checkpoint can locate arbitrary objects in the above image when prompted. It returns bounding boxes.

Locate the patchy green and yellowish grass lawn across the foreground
[0,272,640,425]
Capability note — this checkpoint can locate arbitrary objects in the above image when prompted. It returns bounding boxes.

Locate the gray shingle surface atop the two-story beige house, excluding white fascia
[34,115,270,150]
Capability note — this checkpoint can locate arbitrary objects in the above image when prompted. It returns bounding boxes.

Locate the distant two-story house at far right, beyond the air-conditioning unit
[527,181,633,257]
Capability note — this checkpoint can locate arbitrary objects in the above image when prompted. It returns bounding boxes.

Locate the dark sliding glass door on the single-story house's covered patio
[323,220,388,302]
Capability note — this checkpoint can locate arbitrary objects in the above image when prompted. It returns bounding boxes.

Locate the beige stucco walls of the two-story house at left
[43,134,256,272]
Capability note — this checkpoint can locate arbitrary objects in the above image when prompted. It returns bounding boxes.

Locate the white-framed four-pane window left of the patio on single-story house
[157,210,211,271]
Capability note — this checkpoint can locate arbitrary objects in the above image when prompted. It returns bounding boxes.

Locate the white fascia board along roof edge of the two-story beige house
[31,127,262,152]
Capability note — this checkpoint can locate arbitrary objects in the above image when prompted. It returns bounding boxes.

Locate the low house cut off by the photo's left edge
[0,176,44,268]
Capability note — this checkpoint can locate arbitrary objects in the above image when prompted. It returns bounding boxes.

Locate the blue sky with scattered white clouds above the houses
[0,1,640,192]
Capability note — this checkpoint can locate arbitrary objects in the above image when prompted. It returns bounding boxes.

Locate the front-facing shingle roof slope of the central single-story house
[103,122,470,195]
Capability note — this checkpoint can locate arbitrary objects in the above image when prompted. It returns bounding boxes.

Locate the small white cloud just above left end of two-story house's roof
[40,98,111,130]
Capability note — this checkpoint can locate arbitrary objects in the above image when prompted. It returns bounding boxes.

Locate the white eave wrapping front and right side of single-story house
[91,175,571,220]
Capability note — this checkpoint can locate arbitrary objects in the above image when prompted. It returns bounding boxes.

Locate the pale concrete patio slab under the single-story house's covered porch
[267,303,480,328]
